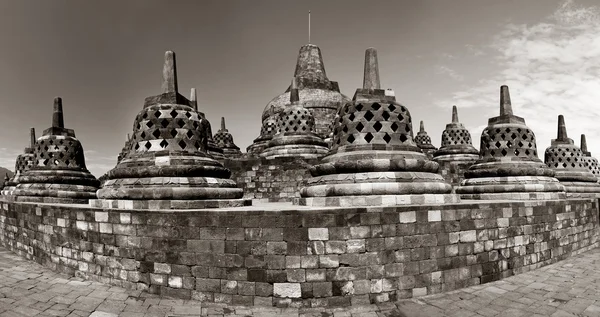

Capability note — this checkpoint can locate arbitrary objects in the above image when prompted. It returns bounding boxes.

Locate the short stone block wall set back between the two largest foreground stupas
[223,157,318,202]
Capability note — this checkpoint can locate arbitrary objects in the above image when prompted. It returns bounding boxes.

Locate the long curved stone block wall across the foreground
[0,199,599,307]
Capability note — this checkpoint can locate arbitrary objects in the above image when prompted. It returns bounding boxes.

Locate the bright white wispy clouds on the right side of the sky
[436,1,600,159]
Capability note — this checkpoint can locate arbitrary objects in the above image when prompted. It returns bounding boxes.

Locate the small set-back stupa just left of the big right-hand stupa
[433,106,479,162]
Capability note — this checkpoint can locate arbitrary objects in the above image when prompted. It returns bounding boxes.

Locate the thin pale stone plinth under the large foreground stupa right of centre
[294,194,460,207]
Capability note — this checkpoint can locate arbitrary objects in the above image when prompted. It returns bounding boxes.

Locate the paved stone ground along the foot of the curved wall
[0,247,600,317]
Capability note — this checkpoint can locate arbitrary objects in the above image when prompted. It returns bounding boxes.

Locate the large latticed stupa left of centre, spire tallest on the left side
[90,51,250,209]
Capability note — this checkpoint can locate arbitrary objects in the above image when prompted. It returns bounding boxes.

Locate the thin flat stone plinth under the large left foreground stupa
[89,199,252,210]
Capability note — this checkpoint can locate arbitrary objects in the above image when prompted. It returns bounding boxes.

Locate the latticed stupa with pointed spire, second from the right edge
[544,115,600,197]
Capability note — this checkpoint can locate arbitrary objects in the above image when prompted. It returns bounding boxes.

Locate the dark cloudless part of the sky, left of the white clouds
[0,0,576,176]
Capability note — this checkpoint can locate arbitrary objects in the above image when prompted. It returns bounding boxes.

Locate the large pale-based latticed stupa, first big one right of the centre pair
[456,86,565,200]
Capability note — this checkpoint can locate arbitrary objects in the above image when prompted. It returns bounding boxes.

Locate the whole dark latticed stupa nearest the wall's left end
[13,97,100,204]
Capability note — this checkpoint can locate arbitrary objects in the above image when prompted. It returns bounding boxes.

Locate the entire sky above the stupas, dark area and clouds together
[0,0,600,177]
